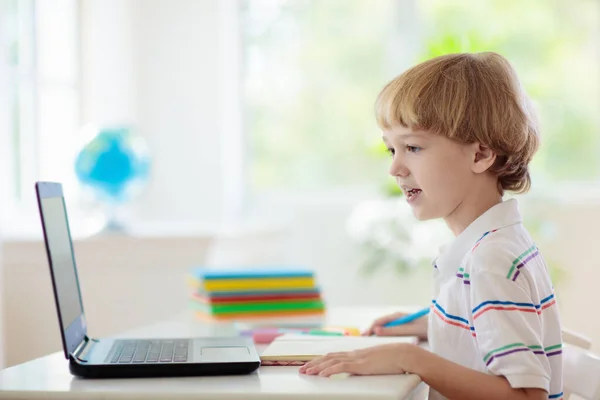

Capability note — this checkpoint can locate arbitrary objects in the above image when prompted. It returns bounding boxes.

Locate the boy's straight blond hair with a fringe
[375,52,540,193]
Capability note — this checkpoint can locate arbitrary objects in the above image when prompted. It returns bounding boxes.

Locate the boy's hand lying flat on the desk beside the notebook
[300,343,425,376]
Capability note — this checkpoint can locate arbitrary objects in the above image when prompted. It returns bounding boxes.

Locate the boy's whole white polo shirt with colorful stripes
[428,199,562,399]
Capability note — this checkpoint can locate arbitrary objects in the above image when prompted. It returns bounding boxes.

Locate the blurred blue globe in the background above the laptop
[75,127,150,205]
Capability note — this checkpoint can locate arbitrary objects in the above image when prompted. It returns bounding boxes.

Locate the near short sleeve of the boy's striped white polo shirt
[471,255,551,392]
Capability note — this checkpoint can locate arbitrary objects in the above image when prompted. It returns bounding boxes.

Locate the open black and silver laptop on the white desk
[35,182,260,378]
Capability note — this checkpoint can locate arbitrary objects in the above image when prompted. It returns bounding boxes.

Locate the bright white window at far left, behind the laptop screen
[0,0,79,225]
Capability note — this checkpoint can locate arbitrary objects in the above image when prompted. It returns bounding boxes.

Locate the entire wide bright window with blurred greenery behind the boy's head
[242,0,600,200]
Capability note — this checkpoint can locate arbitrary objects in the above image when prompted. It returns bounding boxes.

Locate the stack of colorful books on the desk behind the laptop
[189,268,325,320]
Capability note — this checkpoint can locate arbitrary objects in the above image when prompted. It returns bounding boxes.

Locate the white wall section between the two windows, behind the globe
[81,0,235,225]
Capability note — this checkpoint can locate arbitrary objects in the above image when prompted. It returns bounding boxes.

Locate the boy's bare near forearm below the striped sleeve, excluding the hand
[407,347,548,400]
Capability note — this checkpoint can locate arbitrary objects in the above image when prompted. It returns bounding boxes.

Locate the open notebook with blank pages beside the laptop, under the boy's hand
[260,333,418,366]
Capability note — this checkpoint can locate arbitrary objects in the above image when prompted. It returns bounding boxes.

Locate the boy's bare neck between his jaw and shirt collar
[444,185,502,236]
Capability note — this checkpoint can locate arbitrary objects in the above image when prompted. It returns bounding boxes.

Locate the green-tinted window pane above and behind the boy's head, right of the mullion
[418,0,600,183]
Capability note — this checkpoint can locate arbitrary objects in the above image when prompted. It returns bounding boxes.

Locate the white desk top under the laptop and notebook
[0,308,427,400]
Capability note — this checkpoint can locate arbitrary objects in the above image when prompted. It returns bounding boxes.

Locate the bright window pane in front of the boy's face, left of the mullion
[241,0,410,198]
